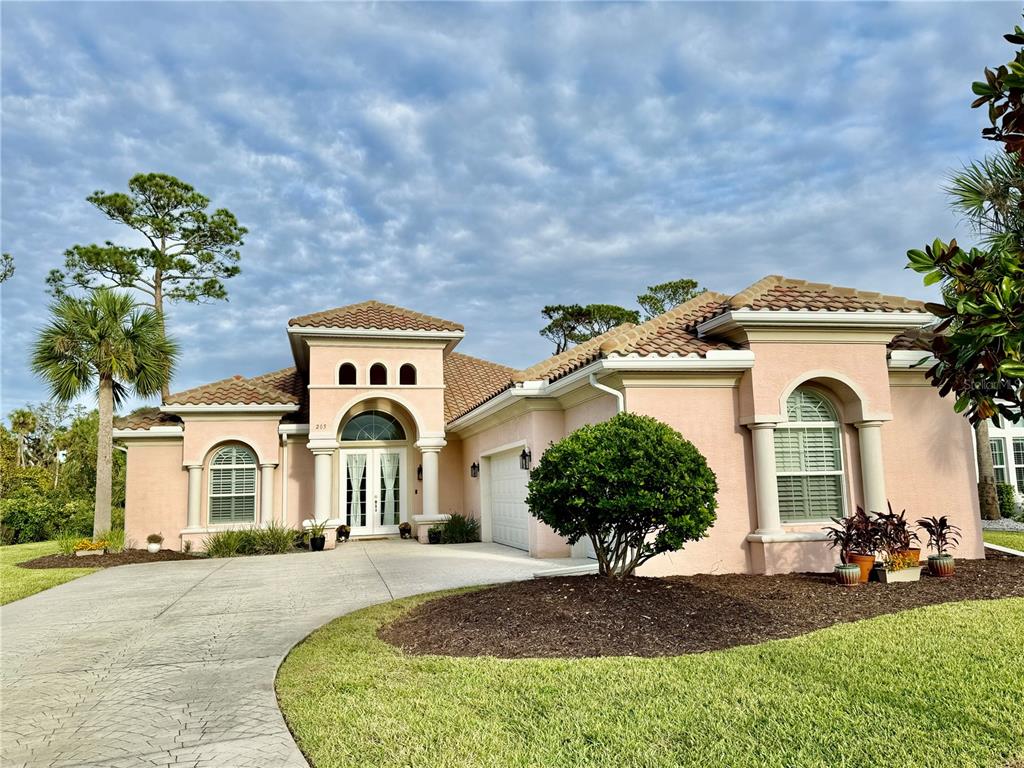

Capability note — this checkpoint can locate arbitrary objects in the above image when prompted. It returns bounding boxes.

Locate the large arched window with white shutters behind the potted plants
[775,387,845,522]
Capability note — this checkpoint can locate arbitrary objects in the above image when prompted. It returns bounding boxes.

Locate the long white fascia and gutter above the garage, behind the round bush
[449,349,754,430]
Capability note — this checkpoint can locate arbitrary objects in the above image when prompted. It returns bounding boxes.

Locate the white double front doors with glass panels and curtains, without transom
[339,447,408,536]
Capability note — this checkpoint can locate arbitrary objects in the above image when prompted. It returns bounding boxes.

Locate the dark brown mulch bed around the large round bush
[378,558,1024,658]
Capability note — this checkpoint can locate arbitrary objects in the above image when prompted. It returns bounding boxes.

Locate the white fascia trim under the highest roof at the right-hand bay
[697,309,936,336]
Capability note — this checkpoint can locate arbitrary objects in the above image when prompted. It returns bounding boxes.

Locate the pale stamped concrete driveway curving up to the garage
[0,541,582,768]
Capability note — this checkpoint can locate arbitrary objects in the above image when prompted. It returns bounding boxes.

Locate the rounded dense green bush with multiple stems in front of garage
[526,414,718,579]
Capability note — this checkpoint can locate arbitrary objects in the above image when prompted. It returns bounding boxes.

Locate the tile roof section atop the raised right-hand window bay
[723,274,926,312]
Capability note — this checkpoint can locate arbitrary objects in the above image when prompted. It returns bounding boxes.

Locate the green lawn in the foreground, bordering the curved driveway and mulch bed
[276,596,1024,768]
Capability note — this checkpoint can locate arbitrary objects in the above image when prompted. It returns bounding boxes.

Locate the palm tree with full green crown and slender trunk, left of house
[32,289,178,537]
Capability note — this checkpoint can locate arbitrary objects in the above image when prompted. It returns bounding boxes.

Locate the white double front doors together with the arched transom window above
[336,408,412,536]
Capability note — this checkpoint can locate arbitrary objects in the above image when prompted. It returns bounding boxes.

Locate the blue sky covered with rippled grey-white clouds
[0,2,1020,413]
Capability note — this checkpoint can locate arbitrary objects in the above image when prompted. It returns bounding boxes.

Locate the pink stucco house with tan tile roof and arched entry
[115,275,983,574]
